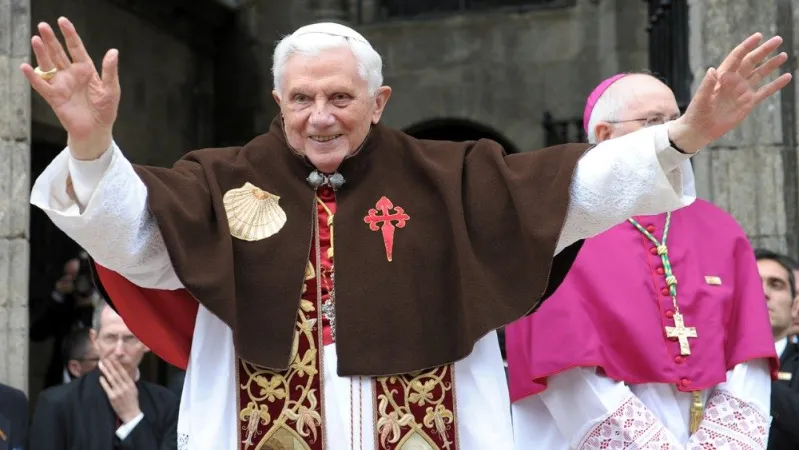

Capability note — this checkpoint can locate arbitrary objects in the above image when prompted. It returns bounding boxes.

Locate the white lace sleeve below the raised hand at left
[31,143,183,289]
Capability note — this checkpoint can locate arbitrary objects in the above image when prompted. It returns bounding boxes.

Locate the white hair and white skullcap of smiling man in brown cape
[272,22,383,96]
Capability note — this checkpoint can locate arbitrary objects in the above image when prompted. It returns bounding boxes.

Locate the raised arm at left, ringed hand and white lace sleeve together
[21,17,191,289]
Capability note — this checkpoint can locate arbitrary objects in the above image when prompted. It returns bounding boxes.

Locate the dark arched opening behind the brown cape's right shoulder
[405,119,519,153]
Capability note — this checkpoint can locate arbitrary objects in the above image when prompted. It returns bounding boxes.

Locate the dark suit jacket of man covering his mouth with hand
[29,370,178,450]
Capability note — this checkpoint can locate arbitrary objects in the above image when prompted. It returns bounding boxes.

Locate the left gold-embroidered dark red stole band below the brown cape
[239,294,324,450]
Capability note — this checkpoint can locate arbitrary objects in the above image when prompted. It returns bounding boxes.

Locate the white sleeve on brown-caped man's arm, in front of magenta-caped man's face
[556,124,696,253]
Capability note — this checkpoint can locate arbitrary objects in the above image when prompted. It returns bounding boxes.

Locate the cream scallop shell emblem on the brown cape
[222,182,286,241]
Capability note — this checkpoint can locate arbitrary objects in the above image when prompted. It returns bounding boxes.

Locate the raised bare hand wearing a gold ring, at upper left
[21,17,120,160]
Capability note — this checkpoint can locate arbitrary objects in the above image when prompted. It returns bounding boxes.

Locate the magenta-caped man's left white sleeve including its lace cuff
[538,367,681,450]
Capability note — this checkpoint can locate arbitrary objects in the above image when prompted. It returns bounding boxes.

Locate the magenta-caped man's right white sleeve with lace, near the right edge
[688,359,771,450]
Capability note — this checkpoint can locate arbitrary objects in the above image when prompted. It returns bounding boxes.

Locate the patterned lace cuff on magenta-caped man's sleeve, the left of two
[574,395,682,450]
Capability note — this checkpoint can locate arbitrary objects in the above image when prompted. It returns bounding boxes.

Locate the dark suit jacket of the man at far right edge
[768,342,799,450]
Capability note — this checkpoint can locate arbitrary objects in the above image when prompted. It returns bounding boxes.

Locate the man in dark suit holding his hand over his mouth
[30,303,178,450]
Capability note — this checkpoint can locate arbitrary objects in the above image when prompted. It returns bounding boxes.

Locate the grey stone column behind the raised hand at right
[689,0,799,256]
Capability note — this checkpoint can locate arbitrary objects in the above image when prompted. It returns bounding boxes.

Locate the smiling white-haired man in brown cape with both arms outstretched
[28,14,790,450]
